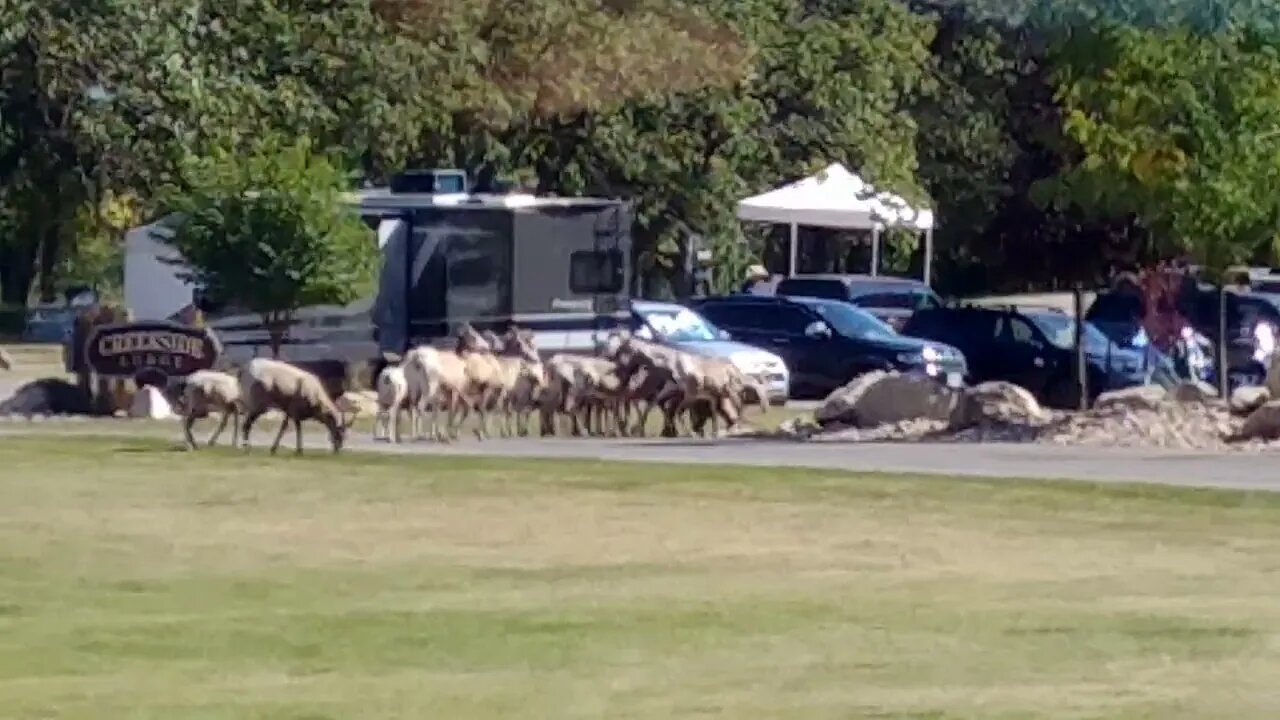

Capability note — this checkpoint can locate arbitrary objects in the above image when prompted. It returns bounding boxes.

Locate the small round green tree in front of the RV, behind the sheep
[157,140,378,355]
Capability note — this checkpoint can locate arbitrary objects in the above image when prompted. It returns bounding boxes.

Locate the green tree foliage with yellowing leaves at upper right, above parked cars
[1050,26,1280,270]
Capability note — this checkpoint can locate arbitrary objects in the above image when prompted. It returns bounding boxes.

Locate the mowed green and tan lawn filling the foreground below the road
[0,437,1280,720]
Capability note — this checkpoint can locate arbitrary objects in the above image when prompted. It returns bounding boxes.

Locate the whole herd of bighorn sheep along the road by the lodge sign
[174,325,768,452]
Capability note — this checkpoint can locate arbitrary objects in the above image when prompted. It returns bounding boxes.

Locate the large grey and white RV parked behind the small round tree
[112,171,631,363]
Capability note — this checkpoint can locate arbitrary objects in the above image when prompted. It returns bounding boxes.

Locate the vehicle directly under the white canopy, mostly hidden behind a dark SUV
[776,275,943,329]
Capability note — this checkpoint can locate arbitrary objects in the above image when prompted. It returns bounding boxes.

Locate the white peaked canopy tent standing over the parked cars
[737,163,933,284]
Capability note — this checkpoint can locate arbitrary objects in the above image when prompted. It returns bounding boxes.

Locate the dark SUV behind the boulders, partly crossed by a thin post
[904,306,1146,407]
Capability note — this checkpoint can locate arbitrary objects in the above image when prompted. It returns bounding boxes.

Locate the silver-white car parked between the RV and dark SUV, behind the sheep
[631,300,791,405]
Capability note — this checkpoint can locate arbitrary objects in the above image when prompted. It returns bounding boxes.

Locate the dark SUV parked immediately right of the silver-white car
[694,295,966,397]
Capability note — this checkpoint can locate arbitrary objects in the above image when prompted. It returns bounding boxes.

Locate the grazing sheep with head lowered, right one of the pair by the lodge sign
[239,357,356,455]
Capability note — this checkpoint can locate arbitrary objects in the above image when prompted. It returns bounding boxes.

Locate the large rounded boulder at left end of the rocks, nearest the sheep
[814,370,959,428]
